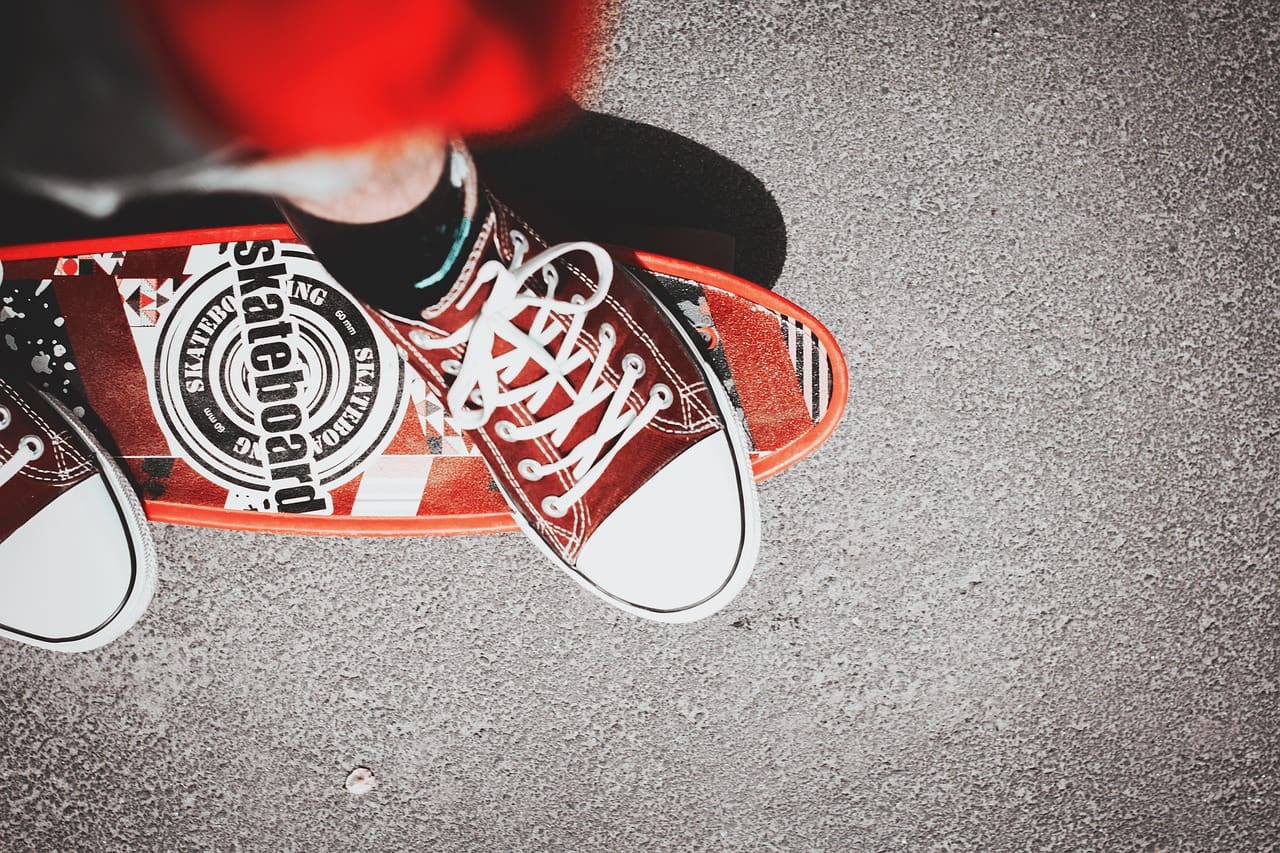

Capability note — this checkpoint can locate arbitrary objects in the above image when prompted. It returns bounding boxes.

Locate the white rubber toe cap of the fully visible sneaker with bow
[577,433,759,622]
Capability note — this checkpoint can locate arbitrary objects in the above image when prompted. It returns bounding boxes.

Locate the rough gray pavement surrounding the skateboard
[0,0,1280,850]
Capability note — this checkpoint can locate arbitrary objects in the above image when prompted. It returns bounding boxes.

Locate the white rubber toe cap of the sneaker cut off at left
[0,476,138,643]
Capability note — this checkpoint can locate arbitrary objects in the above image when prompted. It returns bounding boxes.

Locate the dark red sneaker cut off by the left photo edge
[0,377,155,652]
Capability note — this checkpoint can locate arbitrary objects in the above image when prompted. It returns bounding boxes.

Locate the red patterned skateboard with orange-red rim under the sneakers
[0,225,849,535]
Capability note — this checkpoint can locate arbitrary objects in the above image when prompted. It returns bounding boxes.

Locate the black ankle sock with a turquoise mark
[278,151,489,318]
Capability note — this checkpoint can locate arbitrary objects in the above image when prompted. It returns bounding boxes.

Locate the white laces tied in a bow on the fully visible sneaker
[413,231,673,517]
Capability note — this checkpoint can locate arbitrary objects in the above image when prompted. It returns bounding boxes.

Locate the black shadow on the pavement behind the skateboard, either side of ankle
[0,102,787,287]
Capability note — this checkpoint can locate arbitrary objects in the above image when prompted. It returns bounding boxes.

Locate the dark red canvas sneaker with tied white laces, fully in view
[371,153,759,622]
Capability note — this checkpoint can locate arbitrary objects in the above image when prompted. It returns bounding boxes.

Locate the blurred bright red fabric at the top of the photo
[131,0,596,154]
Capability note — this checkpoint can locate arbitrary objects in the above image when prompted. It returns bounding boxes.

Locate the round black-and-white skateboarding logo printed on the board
[154,241,404,512]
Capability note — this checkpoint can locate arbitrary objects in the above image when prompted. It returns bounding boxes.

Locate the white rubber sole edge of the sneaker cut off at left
[0,394,156,652]
